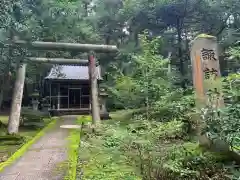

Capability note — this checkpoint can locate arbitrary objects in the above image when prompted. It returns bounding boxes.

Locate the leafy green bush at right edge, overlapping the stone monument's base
[203,74,240,149]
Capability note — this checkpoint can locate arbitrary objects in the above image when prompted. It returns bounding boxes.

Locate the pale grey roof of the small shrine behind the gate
[45,65,102,80]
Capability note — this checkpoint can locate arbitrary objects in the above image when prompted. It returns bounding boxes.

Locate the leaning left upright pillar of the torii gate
[8,64,26,134]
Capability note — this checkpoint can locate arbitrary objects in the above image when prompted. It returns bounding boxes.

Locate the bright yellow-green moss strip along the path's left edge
[0,119,57,172]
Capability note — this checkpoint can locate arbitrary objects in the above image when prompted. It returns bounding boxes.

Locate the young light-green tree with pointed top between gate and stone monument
[108,34,170,108]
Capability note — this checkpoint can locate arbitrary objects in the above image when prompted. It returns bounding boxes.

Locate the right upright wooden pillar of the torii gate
[88,52,100,124]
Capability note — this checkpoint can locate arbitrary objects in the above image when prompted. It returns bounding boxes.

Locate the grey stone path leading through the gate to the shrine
[0,116,76,180]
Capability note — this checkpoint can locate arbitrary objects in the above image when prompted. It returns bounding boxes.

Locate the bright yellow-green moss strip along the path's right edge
[64,116,83,180]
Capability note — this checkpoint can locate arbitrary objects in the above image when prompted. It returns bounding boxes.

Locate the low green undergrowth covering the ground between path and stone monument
[78,112,230,180]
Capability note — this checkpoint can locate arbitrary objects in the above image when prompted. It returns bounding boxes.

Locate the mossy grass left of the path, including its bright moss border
[0,116,56,170]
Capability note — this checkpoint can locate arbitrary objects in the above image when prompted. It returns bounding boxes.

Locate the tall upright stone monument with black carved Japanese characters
[191,34,224,108]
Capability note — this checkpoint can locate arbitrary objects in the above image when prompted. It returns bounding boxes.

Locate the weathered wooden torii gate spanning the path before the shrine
[8,40,118,134]
